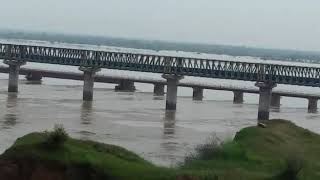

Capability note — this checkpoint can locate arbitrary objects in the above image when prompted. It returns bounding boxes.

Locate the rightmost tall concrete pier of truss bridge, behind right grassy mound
[255,82,277,121]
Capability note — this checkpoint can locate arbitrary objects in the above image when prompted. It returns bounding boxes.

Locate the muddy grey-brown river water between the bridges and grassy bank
[0,74,320,166]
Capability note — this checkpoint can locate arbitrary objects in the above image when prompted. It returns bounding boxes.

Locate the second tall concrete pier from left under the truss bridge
[79,67,100,101]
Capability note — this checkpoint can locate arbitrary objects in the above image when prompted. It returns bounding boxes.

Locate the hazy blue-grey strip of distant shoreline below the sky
[0,30,320,63]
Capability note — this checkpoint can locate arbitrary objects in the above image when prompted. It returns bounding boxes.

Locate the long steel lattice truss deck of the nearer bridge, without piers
[0,44,320,87]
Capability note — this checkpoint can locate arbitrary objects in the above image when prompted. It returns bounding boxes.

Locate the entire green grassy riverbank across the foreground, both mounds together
[0,120,320,180]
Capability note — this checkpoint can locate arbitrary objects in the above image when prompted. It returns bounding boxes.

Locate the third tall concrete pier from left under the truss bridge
[162,74,183,110]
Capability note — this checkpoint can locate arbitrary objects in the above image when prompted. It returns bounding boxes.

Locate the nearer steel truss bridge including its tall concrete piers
[0,44,320,120]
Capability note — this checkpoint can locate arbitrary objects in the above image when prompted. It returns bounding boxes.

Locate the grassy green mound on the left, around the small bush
[1,133,173,179]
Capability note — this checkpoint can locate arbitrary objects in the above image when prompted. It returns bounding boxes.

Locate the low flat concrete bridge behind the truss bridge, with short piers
[0,66,320,112]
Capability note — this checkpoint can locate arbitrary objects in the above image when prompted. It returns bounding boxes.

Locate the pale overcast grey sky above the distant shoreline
[0,0,320,51]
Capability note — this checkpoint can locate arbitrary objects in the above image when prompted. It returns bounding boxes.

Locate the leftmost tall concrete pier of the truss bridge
[3,60,26,92]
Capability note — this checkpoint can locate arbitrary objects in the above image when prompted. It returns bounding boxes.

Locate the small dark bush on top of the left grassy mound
[45,124,69,148]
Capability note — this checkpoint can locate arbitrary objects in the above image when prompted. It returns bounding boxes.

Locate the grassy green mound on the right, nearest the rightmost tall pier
[181,120,320,179]
